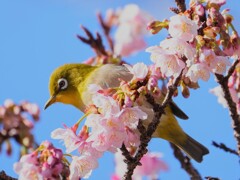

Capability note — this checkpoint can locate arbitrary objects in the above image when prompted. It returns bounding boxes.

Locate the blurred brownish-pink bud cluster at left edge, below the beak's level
[0,99,40,155]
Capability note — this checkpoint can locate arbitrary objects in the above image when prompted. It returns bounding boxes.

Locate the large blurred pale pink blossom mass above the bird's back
[114,4,152,56]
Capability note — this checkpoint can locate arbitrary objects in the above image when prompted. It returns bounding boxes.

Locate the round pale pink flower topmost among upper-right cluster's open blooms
[168,15,198,41]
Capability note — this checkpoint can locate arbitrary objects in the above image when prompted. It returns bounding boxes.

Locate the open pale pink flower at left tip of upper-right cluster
[146,46,185,77]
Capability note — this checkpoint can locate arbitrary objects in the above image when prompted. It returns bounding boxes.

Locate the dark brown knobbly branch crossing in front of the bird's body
[121,73,182,180]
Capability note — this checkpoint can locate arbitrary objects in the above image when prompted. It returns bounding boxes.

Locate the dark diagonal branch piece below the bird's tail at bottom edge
[170,143,202,180]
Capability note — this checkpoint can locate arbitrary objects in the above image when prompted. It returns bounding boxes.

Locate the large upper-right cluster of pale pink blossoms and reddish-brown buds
[146,0,240,97]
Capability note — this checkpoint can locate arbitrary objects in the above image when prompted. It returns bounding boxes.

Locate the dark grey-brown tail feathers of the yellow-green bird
[174,134,209,162]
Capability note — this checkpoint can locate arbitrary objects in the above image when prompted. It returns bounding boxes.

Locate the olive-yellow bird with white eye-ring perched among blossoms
[44,63,209,163]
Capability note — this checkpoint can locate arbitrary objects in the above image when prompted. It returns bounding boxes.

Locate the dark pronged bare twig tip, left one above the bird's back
[77,26,108,56]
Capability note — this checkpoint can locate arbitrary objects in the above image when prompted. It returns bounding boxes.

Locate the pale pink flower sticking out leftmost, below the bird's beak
[51,127,81,153]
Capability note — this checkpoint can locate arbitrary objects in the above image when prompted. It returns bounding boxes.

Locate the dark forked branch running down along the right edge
[215,59,240,155]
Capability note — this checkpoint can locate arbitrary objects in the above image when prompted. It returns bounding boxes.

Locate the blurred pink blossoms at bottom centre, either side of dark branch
[112,151,168,180]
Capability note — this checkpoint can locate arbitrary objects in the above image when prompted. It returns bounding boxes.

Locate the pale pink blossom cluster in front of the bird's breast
[52,85,147,179]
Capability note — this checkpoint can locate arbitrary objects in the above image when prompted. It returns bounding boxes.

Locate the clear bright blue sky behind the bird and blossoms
[0,0,240,180]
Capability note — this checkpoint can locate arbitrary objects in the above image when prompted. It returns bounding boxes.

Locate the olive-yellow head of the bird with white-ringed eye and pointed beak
[44,64,93,109]
